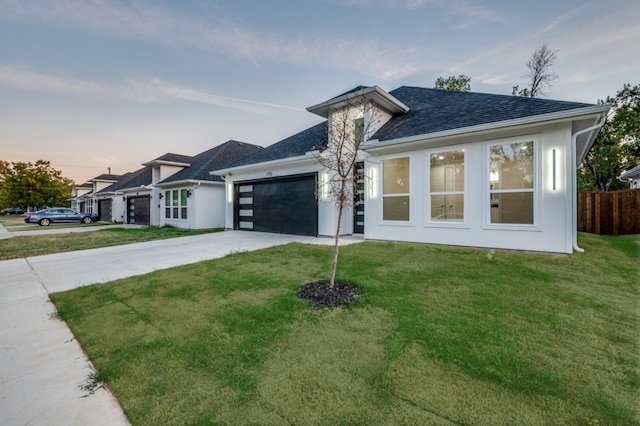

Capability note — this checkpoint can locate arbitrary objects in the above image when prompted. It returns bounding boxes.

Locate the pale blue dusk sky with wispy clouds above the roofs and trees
[0,0,640,183]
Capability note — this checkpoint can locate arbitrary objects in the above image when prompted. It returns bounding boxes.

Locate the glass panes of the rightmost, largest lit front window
[488,141,535,225]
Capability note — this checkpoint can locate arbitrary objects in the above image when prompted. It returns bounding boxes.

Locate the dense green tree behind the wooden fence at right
[578,84,640,191]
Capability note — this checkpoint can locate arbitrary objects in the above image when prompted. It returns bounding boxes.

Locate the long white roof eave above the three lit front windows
[362,105,610,152]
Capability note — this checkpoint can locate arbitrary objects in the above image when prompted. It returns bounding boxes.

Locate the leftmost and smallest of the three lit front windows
[382,157,410,221]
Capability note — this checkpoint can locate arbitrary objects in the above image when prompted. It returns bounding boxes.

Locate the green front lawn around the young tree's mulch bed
[52,235,640,425]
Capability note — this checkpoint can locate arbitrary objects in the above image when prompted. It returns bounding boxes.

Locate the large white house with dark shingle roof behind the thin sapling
[212,86,609,253]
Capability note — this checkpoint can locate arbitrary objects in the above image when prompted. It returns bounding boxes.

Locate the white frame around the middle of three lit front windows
[424,145,470,228]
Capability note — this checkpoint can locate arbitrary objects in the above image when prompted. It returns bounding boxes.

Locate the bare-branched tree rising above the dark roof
[511,43,558,98]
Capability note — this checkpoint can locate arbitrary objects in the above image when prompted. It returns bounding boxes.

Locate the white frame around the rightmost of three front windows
[482,135,543,231]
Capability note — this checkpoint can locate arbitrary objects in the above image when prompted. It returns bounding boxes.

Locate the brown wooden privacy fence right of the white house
[578,189,640,235]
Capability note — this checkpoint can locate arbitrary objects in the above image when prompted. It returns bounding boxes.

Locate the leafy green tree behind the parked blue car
[0,160,73,208]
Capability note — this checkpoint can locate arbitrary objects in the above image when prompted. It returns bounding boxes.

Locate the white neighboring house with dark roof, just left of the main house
[93,141,262,229]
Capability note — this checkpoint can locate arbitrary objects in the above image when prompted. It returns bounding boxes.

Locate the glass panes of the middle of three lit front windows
[429,150,464,222]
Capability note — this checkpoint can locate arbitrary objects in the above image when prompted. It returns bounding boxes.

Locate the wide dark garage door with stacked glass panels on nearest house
[234,174,318,237]
